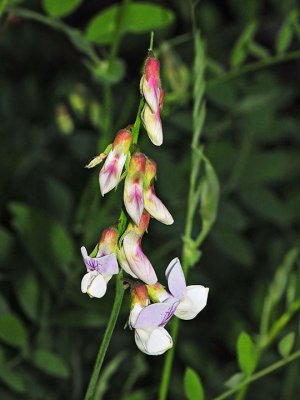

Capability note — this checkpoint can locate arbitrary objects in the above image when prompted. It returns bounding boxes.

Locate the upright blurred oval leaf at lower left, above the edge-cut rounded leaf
[15,271,39,321]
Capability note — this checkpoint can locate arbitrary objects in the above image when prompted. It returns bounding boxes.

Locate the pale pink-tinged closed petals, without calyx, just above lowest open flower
[123,231,157,285]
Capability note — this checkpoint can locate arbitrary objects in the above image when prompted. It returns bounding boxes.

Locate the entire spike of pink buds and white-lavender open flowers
[81,52,208,355]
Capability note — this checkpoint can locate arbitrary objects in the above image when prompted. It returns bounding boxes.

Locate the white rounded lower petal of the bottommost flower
[135,328,173,356]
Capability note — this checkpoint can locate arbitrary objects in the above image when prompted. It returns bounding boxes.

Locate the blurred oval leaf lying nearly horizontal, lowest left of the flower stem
[28,349,70,379]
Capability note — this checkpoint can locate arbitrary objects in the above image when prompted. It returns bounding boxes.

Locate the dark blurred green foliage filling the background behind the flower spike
[0,0,300,400]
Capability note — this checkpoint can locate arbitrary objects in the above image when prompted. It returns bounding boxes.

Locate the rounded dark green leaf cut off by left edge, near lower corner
[0,313,28,349]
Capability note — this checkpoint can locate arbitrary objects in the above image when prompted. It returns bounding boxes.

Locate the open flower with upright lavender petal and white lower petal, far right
[166,258,209,320]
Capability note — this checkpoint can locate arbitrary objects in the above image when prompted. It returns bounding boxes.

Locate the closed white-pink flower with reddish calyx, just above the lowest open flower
[118,211,157,284]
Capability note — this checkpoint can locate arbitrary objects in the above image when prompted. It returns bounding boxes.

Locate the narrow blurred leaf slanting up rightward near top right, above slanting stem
[230,21,257,67]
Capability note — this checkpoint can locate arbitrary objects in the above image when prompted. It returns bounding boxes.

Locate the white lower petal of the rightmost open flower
[175,285,209,320]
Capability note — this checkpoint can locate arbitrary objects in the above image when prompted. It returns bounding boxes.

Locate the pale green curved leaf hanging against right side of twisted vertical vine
[199,156,220,243]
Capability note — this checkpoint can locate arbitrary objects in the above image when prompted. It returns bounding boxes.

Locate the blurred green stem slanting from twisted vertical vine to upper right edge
[207,50,300,88]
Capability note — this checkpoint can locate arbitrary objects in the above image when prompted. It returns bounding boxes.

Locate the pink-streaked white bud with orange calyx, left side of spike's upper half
[99,129,132,196]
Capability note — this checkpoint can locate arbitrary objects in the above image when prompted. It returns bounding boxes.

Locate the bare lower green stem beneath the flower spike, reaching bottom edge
[84,271,124,400]
